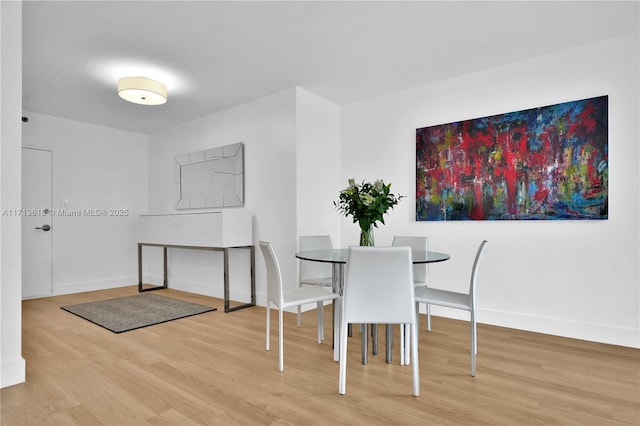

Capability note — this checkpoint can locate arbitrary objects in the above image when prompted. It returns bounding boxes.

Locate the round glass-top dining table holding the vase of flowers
[296,249,451,364]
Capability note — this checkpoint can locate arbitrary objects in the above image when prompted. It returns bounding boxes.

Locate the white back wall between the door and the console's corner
[22,112,148,294]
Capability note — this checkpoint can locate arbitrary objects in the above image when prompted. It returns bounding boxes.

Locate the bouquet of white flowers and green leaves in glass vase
[333,178,404,245]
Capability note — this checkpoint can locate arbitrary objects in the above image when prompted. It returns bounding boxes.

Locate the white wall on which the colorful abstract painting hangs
[342,34,640,347]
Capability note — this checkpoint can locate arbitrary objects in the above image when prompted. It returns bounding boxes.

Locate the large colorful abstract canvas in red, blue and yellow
[416,96,609,221]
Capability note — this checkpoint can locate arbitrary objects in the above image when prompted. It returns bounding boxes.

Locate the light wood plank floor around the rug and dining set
[0,286,640,426]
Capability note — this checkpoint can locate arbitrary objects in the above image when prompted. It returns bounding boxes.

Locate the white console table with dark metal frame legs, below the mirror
[138,211,256,312]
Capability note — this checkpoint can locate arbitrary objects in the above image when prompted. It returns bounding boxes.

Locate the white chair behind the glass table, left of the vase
[298,235,333,327]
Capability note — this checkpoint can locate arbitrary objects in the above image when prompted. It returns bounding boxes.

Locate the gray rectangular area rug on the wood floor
[62,293,217,333]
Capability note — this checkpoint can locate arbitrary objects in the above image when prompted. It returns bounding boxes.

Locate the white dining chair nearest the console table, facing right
[258,241,339,371]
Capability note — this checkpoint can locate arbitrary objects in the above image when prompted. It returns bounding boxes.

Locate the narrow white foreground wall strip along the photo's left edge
[0,1,26,387]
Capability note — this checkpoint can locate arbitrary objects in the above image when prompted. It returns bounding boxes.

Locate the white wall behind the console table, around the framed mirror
[145,88,297,305]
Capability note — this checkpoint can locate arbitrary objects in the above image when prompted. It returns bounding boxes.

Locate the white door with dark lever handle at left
[20,148,54,299]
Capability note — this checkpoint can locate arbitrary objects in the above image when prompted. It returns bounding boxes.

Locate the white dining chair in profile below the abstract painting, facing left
[415,240,487,377]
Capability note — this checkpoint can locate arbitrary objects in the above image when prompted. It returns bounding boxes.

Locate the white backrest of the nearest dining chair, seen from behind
[342,247,416,324]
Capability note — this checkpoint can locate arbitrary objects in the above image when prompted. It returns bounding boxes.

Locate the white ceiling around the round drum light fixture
[22,0,639,134]
